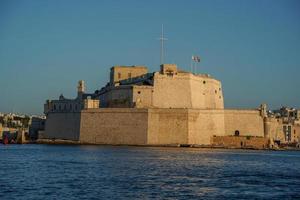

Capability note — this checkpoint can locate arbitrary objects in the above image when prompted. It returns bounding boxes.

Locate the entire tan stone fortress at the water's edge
[42,64,300,148]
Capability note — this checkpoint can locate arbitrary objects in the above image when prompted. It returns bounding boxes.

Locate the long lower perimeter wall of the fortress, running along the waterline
[45,108,264,145]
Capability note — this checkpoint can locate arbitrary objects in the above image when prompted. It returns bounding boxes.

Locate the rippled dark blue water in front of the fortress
[0,145,300,199]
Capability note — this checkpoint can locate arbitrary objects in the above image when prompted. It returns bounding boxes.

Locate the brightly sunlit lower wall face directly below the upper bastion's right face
[188,109,225,145]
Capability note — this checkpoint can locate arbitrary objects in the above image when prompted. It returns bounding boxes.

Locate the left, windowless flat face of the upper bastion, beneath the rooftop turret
[153,73,192,108]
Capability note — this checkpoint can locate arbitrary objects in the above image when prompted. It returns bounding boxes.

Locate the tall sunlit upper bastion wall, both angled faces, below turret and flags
[153,72,224,109]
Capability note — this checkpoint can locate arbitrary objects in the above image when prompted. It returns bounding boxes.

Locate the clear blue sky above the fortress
[0,0,300,114]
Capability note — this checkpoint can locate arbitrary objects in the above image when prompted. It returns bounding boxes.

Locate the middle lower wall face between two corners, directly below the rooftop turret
[148,109,188,145]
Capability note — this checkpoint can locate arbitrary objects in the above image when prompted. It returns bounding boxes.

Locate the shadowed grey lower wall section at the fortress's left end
[44,112,80,140]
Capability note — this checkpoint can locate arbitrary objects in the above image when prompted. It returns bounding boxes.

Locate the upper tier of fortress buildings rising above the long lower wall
[96,64,224,109]
